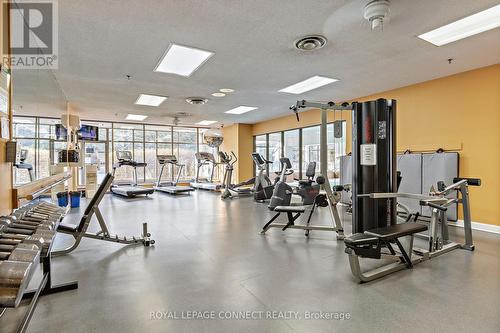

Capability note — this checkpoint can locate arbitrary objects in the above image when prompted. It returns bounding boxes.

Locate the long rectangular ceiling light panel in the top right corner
[418,5,500,46]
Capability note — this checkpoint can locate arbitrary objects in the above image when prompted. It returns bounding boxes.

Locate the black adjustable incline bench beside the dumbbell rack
[52,173,155,256]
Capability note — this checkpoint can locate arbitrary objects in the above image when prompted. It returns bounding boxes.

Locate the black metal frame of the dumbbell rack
[0,203,78,332]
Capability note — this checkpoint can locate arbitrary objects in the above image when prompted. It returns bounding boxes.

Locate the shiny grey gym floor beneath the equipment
[0,191,500,333]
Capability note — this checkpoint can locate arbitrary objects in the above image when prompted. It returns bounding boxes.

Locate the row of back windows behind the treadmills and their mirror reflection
[13,117,214,185]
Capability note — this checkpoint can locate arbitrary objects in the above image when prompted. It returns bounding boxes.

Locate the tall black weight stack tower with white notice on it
[352,99,397,233]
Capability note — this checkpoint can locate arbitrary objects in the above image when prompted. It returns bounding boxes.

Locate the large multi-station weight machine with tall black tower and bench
[291,99,481,282]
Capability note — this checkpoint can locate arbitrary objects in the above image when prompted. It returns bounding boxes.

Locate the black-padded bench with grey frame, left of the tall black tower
[260,194,338,236]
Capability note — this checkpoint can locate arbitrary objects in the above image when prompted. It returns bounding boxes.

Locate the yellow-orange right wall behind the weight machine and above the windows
[247,64,500,225]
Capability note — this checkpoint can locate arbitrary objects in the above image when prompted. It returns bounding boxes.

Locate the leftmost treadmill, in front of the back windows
[111,150,155,198]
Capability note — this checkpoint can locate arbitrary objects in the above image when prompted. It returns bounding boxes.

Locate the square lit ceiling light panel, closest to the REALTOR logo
[154,44,214,77]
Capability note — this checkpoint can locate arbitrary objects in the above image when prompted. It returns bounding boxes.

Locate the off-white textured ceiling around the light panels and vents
[10,0,500,124]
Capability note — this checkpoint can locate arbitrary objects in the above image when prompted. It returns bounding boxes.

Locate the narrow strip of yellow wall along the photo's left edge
[0,4,12,215]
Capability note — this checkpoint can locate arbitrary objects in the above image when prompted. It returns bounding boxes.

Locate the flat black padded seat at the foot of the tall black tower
[344,222,427,268]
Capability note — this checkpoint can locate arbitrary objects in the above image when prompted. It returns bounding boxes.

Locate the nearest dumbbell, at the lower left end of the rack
[0,261,35,307]
